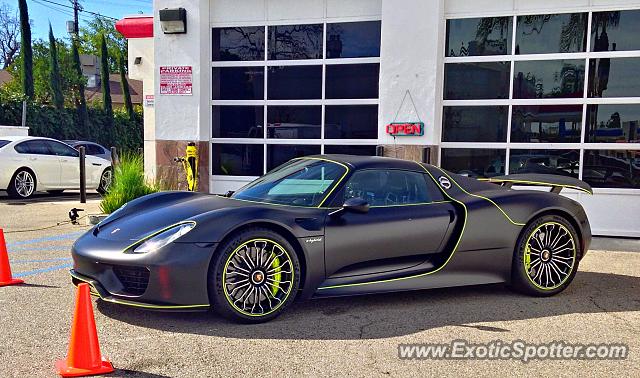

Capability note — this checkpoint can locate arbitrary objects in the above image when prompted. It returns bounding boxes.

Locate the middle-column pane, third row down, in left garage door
[267,106,322,139]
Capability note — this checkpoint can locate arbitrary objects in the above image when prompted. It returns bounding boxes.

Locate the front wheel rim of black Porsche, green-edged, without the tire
[222,238,295,317]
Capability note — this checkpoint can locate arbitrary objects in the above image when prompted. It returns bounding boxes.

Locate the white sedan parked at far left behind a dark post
[0,136,113,198]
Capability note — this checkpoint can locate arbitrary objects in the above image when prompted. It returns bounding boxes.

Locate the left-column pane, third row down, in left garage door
[212,106,264,138]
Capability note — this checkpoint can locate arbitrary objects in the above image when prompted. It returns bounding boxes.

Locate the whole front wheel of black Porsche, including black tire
[208,228,300,323]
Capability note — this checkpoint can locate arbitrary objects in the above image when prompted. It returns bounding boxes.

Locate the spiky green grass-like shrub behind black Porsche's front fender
[100,153,159,214]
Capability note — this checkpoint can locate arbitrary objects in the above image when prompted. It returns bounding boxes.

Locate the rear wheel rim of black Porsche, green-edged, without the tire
[523,221,577,290]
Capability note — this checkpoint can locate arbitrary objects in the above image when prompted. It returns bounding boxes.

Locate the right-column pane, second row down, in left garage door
[325,64,380,99]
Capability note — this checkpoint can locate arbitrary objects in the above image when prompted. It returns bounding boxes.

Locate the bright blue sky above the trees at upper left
[0,0,153,40]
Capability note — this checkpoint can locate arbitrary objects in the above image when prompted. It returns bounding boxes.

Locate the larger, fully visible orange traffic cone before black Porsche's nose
[56,283,113,377]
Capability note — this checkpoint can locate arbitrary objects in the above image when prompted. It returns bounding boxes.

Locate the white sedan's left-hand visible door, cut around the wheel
[14,139,60,190]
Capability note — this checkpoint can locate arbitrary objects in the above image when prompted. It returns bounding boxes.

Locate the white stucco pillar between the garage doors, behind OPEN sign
[378,0,444,145]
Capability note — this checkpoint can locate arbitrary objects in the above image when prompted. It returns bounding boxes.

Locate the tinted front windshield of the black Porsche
[231,159,347,207]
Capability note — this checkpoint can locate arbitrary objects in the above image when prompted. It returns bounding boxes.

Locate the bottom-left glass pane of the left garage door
[211,143,264,176]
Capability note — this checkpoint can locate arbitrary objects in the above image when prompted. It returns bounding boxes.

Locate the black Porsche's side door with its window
[325,169,455,277]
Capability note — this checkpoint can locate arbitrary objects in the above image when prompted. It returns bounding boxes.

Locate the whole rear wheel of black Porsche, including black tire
[511,215,581,297]
